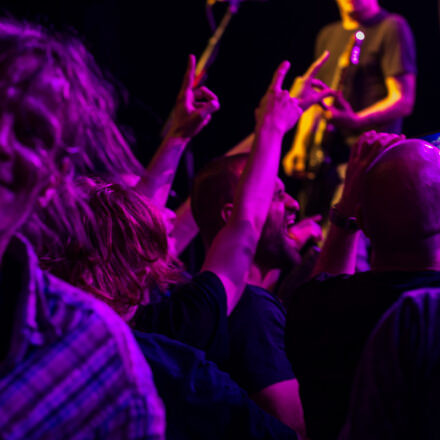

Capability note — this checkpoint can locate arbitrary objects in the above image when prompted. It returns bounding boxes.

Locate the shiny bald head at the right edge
[361,139,440,252]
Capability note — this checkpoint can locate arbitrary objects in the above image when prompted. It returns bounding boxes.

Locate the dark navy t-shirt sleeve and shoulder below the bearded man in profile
[224,285,295,393]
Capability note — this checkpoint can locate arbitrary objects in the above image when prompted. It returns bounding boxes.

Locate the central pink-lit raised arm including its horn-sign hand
[202,61,302,313]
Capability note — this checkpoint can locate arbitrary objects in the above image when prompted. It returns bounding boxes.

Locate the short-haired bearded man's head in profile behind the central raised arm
[191,154,300,269]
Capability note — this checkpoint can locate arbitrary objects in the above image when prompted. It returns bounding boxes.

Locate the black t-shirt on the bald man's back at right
[286,271,440,440]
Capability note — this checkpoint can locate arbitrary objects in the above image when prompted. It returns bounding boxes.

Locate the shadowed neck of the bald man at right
[371,249,440,272]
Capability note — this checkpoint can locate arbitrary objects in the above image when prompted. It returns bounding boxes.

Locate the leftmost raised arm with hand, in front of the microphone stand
[135,55,220,207]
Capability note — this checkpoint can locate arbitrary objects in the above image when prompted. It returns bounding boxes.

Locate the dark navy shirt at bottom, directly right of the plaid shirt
[135,332,297,440]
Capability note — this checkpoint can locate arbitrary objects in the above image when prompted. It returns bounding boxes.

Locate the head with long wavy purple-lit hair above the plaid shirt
[0,20,142,257]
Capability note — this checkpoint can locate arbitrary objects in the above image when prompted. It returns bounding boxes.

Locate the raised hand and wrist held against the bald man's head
[338,131,405,217]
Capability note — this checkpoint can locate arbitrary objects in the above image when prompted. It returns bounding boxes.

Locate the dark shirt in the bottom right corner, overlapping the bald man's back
[340,288,440,440]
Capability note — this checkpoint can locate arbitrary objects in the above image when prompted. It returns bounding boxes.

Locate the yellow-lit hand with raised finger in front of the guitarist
[290,50,335,110]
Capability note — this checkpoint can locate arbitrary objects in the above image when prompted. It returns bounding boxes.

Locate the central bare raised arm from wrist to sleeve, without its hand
[202,124,282,314]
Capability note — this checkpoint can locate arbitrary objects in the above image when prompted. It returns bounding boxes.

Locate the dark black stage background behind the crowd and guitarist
[1,0,440,192]
